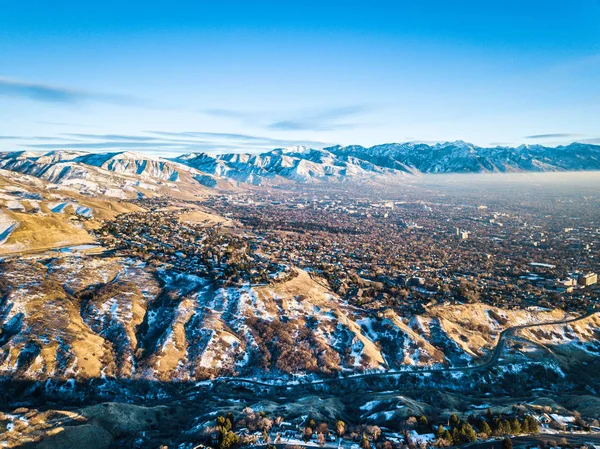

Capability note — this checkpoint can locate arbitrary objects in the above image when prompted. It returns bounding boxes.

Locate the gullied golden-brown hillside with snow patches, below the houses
[0,255,600,381]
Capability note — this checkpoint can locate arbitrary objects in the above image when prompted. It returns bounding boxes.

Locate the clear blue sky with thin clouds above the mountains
[0,0,600,155]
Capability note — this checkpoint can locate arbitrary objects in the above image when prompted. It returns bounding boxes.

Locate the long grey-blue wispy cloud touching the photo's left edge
[0,78,144,105]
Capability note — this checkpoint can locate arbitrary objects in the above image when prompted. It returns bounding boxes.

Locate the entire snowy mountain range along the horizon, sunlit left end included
[0,141,600,192]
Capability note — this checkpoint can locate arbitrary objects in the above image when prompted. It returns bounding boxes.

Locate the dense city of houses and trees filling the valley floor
[99,180,600,313]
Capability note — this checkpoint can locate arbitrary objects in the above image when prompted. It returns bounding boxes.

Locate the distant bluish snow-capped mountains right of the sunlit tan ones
[173,141,600,184]
